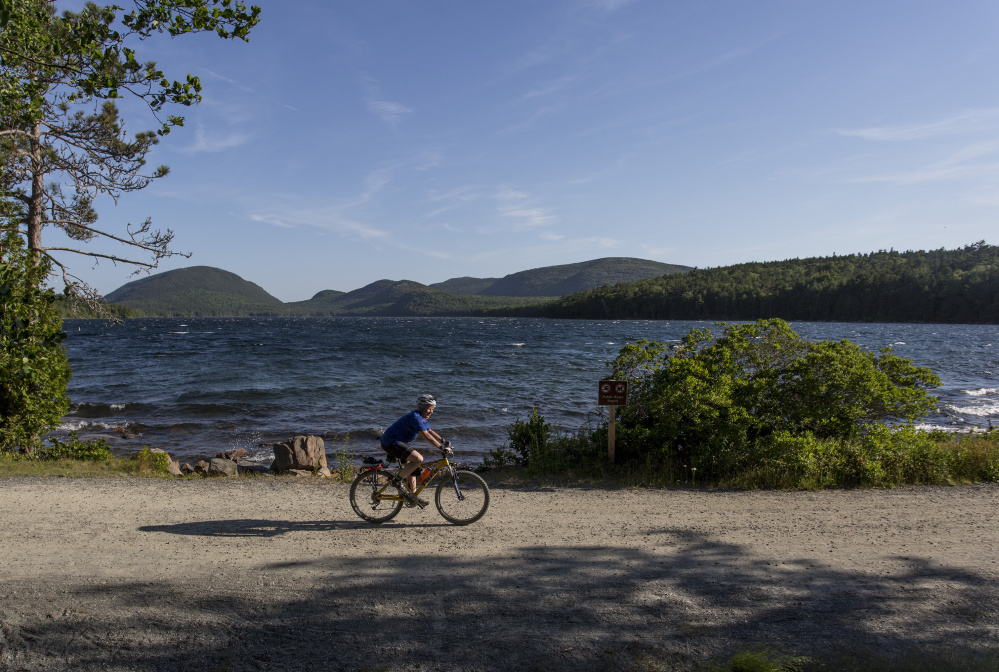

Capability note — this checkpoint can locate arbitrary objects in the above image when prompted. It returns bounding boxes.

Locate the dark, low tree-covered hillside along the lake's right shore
[520,241,999,323]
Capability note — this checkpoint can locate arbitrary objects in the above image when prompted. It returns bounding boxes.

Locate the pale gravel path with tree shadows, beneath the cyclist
[0,478,999,670]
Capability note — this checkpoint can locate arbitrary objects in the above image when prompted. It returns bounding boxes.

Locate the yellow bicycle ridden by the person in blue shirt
[350,448,489,525]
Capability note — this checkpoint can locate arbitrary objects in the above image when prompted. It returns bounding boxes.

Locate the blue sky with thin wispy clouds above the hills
[50,0,999,301]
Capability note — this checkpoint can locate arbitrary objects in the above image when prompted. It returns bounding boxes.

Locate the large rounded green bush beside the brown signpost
[610,320,940,484]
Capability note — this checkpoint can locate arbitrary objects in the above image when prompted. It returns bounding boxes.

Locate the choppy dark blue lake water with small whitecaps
[63,317,999,462]
